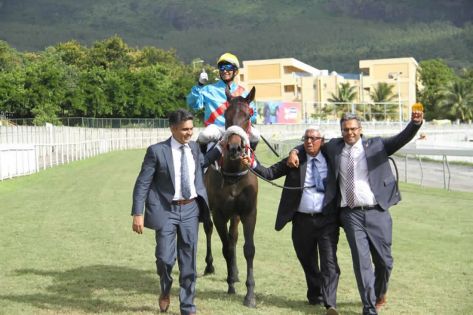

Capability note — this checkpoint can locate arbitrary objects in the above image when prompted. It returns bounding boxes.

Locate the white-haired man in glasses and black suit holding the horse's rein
[243,128,340,315]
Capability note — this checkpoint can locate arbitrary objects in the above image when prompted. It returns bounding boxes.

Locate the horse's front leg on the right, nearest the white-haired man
[241,210,256,307]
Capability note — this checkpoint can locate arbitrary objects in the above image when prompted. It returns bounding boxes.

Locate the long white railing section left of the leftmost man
[0,126,184,180]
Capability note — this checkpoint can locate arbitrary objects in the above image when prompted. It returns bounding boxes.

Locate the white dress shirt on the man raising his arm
[340,138,377,207]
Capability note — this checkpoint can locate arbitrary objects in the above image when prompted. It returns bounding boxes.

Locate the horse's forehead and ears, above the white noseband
[224,87,256,130]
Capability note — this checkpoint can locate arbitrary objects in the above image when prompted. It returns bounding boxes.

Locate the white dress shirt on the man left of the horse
[171,137,197,200]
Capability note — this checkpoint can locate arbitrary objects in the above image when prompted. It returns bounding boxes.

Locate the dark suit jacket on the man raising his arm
[322,122,421,210]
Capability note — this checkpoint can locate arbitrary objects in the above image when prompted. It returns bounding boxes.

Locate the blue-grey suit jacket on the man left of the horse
[131,138,220,230]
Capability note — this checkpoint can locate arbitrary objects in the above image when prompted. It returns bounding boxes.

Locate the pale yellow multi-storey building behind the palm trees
[239,58,418,123]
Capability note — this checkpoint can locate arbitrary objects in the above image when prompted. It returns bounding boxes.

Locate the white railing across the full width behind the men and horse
[0,121,473,184]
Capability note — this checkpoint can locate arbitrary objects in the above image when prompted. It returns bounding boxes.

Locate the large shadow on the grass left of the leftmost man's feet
[0,265,159,313]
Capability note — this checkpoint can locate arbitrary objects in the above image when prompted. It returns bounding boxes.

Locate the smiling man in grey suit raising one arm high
[288,111,423,314]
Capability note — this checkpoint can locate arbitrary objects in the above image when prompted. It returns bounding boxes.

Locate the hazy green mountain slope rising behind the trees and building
[0,0,473,72]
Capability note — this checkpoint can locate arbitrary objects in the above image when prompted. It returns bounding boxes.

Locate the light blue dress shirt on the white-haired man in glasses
[297,152,327,213]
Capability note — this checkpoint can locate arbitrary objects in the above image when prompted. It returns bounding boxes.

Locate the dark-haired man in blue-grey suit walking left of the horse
[131,109,220,315]
